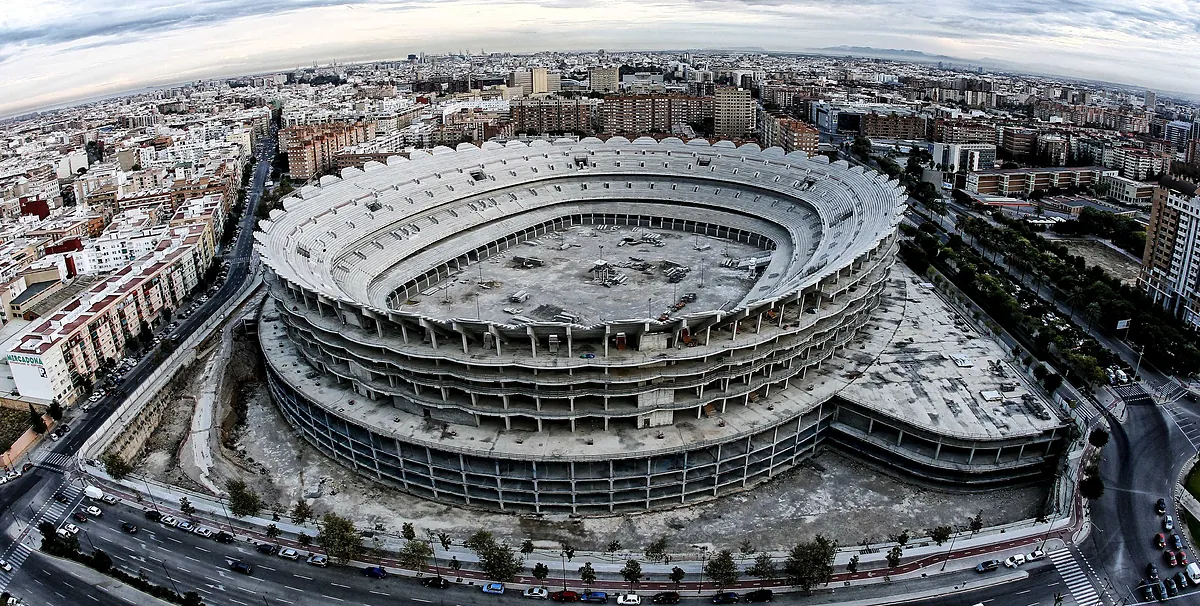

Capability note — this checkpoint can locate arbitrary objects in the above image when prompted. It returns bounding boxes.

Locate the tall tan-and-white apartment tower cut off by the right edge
[1138,179,1200,326]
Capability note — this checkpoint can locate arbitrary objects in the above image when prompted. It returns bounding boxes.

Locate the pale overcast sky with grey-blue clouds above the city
[0,0,1200,115]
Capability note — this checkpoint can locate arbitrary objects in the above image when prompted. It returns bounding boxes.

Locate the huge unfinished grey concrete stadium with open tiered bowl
[256,137,1066,515]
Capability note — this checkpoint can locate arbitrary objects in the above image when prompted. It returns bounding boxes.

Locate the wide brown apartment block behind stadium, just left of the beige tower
[600,95,713,136]
